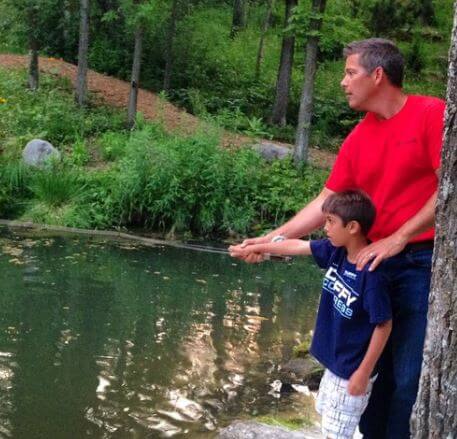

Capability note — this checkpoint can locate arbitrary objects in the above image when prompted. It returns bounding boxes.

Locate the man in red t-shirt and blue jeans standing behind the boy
[230,38,445,438]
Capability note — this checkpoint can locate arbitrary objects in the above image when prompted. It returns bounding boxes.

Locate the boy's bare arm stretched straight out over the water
[229,239,311,259]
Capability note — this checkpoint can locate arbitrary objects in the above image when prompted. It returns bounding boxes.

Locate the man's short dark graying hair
[343,38,405,87]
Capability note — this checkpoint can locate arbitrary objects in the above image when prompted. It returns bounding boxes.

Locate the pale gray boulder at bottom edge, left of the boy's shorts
[218,421,315,439]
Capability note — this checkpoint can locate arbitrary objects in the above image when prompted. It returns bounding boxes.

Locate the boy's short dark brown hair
[322,189,376,236]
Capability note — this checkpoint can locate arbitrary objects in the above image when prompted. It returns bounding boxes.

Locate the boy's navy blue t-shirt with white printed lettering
[310,239,392,379]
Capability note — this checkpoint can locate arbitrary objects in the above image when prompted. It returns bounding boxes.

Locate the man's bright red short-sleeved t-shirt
[325,96,445,242]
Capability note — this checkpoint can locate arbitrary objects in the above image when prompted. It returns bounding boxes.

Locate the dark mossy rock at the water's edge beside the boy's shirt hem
[279,355,325,392]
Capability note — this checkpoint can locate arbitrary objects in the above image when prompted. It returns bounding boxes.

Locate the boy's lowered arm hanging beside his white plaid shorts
[348,320,392,396]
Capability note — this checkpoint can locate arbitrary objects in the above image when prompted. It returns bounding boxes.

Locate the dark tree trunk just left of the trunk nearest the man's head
[270,0,297,126]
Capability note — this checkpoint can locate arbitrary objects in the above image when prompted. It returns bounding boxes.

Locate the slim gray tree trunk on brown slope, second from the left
[75,0,89,106]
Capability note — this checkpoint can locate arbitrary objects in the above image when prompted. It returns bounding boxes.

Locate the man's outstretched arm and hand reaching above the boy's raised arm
[234,187,334,263]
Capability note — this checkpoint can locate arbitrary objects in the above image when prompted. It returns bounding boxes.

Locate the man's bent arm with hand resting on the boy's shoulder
[356,186,438,271]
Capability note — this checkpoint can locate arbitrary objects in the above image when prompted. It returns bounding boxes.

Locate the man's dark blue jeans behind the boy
[360,250,432,439]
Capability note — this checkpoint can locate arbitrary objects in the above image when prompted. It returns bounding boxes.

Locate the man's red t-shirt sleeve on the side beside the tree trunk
[425,99,446,171]
